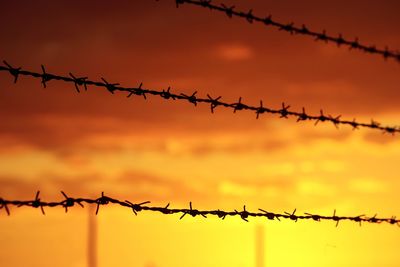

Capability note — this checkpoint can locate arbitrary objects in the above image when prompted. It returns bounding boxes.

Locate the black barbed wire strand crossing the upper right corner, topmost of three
[171,0,400,63]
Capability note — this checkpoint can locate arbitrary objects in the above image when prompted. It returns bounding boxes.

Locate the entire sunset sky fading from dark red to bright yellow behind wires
[0,0,400,267]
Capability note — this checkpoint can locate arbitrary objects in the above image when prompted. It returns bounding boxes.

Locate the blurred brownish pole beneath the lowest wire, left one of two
[87,205,97,267]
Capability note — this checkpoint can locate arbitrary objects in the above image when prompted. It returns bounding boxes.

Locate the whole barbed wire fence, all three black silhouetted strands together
[0,0,400,233]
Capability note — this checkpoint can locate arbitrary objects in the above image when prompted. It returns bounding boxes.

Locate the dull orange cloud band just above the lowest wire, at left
[0,171,220,202]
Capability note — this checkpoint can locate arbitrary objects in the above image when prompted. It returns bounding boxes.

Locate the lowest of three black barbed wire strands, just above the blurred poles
[0,191,400,226]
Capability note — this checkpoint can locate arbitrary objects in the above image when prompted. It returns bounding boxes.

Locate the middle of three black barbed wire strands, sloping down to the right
[0,61,400,134]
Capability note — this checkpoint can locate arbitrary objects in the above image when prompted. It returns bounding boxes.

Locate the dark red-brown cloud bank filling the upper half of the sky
[0,0,400,155]
